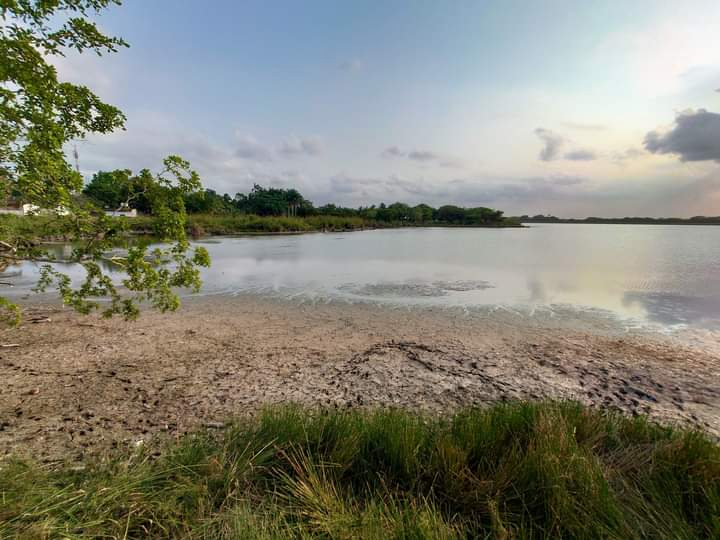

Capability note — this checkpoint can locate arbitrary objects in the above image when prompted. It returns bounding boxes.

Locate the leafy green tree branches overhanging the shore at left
[0,0,209,320]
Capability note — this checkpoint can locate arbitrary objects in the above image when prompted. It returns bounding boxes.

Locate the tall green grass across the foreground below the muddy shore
[0,403,720,539]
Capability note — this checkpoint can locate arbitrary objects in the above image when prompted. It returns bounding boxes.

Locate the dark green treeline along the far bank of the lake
[83,176,520,227]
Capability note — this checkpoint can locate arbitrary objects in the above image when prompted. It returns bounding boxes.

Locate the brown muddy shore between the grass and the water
[0,297,720,460]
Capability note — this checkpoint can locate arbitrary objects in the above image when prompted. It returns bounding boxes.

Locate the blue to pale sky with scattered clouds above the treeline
[56,0,720,217]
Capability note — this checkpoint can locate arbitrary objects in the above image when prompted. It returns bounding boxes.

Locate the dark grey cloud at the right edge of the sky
[644,109,720,162]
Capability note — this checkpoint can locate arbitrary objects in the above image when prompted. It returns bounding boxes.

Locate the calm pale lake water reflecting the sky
[3,224,720,329]
